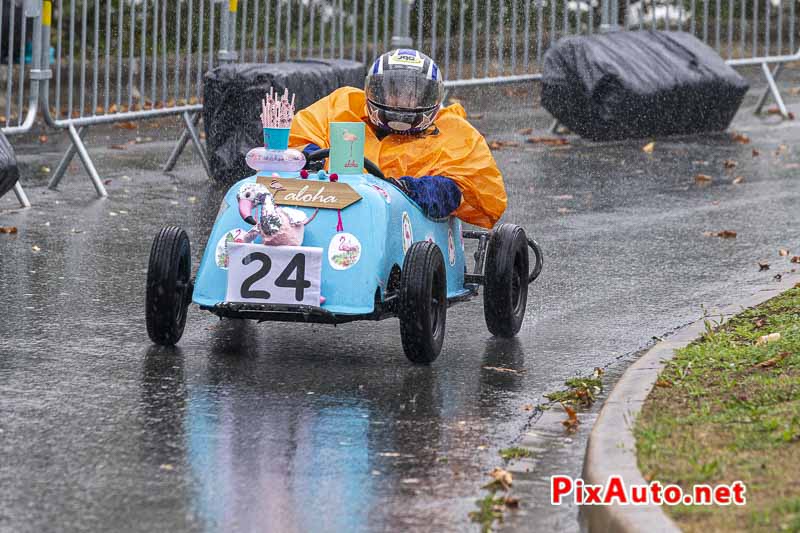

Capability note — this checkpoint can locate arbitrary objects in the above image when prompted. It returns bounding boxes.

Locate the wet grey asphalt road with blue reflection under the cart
[0,76,800,531]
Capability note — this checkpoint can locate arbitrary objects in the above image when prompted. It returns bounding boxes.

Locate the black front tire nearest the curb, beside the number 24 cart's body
[398,241,447,365]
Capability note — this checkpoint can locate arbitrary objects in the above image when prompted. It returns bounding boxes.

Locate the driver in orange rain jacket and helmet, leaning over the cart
[289,50,506,228]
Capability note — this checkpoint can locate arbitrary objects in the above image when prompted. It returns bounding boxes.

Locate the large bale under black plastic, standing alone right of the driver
[542,31,748,141]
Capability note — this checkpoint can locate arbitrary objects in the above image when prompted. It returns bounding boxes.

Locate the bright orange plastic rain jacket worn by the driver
[289,87,507,228]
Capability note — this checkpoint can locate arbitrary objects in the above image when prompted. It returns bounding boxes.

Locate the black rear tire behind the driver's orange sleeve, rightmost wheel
[483,224,528,337]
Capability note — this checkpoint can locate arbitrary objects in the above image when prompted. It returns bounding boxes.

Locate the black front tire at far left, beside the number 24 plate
[145,226,192,346]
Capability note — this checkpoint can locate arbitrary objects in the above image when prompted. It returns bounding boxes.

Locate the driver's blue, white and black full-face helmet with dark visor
[364,49,444,134]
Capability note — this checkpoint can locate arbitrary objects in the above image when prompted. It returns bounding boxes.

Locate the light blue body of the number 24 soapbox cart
[192,172,469,315]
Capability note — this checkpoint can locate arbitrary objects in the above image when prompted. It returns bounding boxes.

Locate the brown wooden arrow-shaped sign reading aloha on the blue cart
[256,176,361,209]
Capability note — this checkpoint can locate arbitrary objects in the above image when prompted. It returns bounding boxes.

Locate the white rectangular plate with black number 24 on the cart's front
[225,243,322,306]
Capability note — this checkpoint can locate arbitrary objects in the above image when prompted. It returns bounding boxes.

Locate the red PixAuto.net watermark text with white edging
[550,476,747,505]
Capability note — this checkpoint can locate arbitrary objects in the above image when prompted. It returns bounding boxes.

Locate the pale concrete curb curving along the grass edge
[581,273,800,533]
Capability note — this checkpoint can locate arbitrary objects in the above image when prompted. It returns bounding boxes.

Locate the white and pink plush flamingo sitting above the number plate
[236,183,316,246]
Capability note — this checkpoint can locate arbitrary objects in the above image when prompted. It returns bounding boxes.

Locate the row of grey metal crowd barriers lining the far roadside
[0,0,800,205]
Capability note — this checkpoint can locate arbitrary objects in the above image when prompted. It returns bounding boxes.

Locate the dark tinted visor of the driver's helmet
[365,69,443,111]
